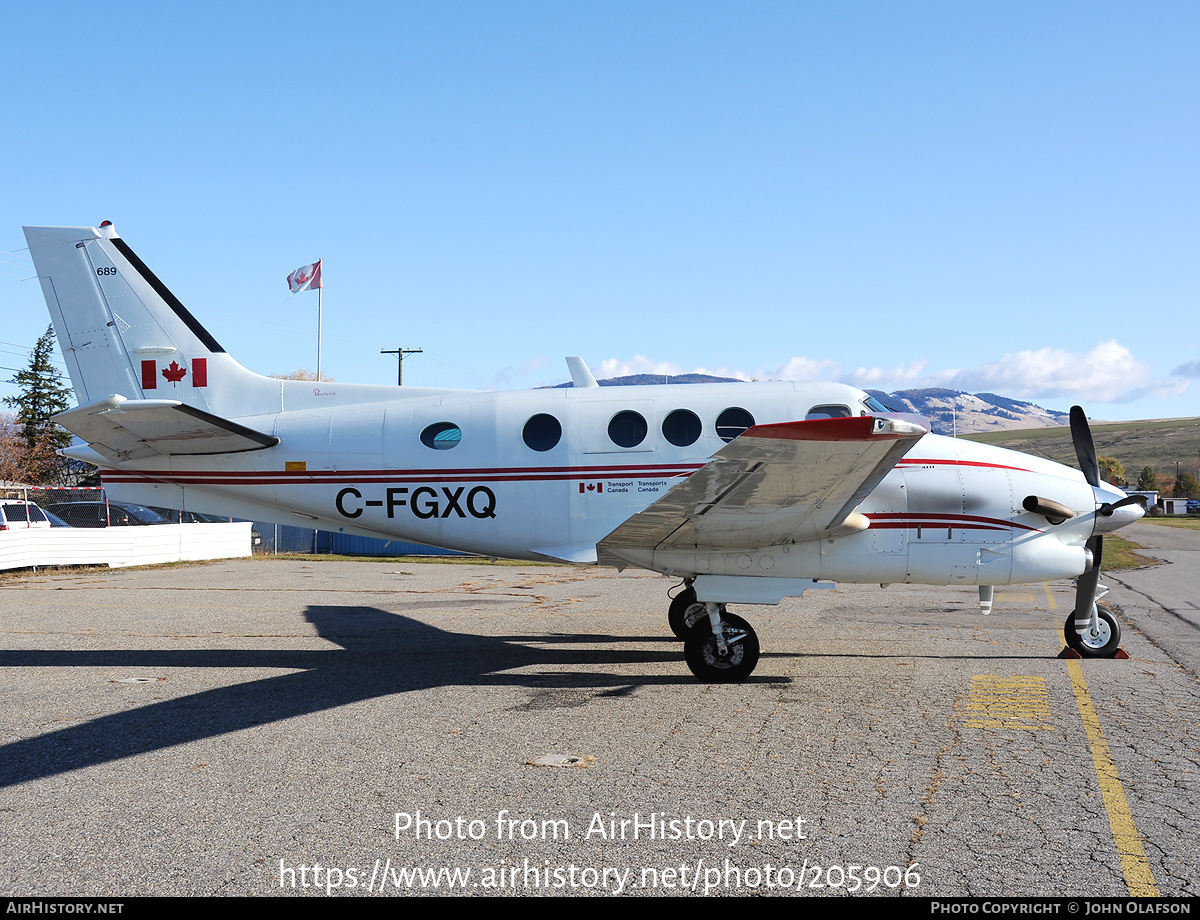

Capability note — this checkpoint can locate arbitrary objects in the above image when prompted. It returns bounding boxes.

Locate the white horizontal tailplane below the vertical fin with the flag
[54,396,280,462]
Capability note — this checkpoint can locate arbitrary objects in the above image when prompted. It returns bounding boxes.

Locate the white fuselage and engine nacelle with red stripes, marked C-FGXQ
[96,383,1123,584]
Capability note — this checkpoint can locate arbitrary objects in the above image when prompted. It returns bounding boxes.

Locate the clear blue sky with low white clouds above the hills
[0,2,1200,419]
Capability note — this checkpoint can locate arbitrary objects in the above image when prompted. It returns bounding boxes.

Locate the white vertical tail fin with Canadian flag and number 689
[25,221,282,417]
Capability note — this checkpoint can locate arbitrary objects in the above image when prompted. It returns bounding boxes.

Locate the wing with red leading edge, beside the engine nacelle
[598,415,929,564]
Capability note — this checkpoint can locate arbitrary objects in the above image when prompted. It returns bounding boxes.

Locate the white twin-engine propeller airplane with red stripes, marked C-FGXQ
[25,221,1144,681]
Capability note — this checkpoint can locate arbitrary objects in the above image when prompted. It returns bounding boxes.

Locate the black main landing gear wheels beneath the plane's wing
[667,583,758,684]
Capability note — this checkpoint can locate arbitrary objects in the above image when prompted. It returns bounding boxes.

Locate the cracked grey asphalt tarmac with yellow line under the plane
[0,525,1200,898]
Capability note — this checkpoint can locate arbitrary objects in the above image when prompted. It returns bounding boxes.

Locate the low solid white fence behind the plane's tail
[0,522,251,570]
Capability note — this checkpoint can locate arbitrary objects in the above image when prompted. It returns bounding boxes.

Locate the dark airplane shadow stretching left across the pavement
[0,606,692,787]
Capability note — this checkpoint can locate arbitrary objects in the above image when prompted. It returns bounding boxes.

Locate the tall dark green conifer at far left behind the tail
[5,326,71,485]
